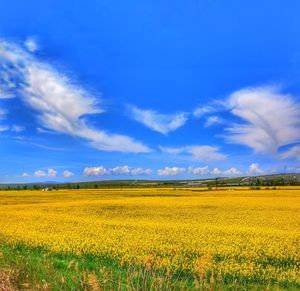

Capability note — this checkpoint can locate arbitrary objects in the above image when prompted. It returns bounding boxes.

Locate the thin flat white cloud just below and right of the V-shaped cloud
[159,145,227,161]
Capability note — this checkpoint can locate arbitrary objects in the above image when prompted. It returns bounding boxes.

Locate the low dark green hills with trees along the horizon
[0,173,300,190]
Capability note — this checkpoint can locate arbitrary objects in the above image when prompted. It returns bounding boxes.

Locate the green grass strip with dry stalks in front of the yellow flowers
[0,241,299,290]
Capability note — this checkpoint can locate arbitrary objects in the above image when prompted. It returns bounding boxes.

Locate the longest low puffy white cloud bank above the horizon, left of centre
[83,165,152,176]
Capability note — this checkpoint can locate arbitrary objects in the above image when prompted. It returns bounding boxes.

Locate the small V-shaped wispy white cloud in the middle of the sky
[129,106,188,135]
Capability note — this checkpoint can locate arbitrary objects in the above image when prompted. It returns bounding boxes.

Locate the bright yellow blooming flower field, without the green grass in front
[0,188,300,283]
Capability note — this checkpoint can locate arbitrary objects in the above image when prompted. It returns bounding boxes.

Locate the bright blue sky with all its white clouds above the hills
[0,0,300,183]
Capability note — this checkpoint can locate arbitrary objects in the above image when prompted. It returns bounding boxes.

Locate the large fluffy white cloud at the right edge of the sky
[227,87,300,154]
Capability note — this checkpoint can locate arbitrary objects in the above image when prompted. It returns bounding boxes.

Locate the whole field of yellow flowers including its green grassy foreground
[0,187,300,290]
